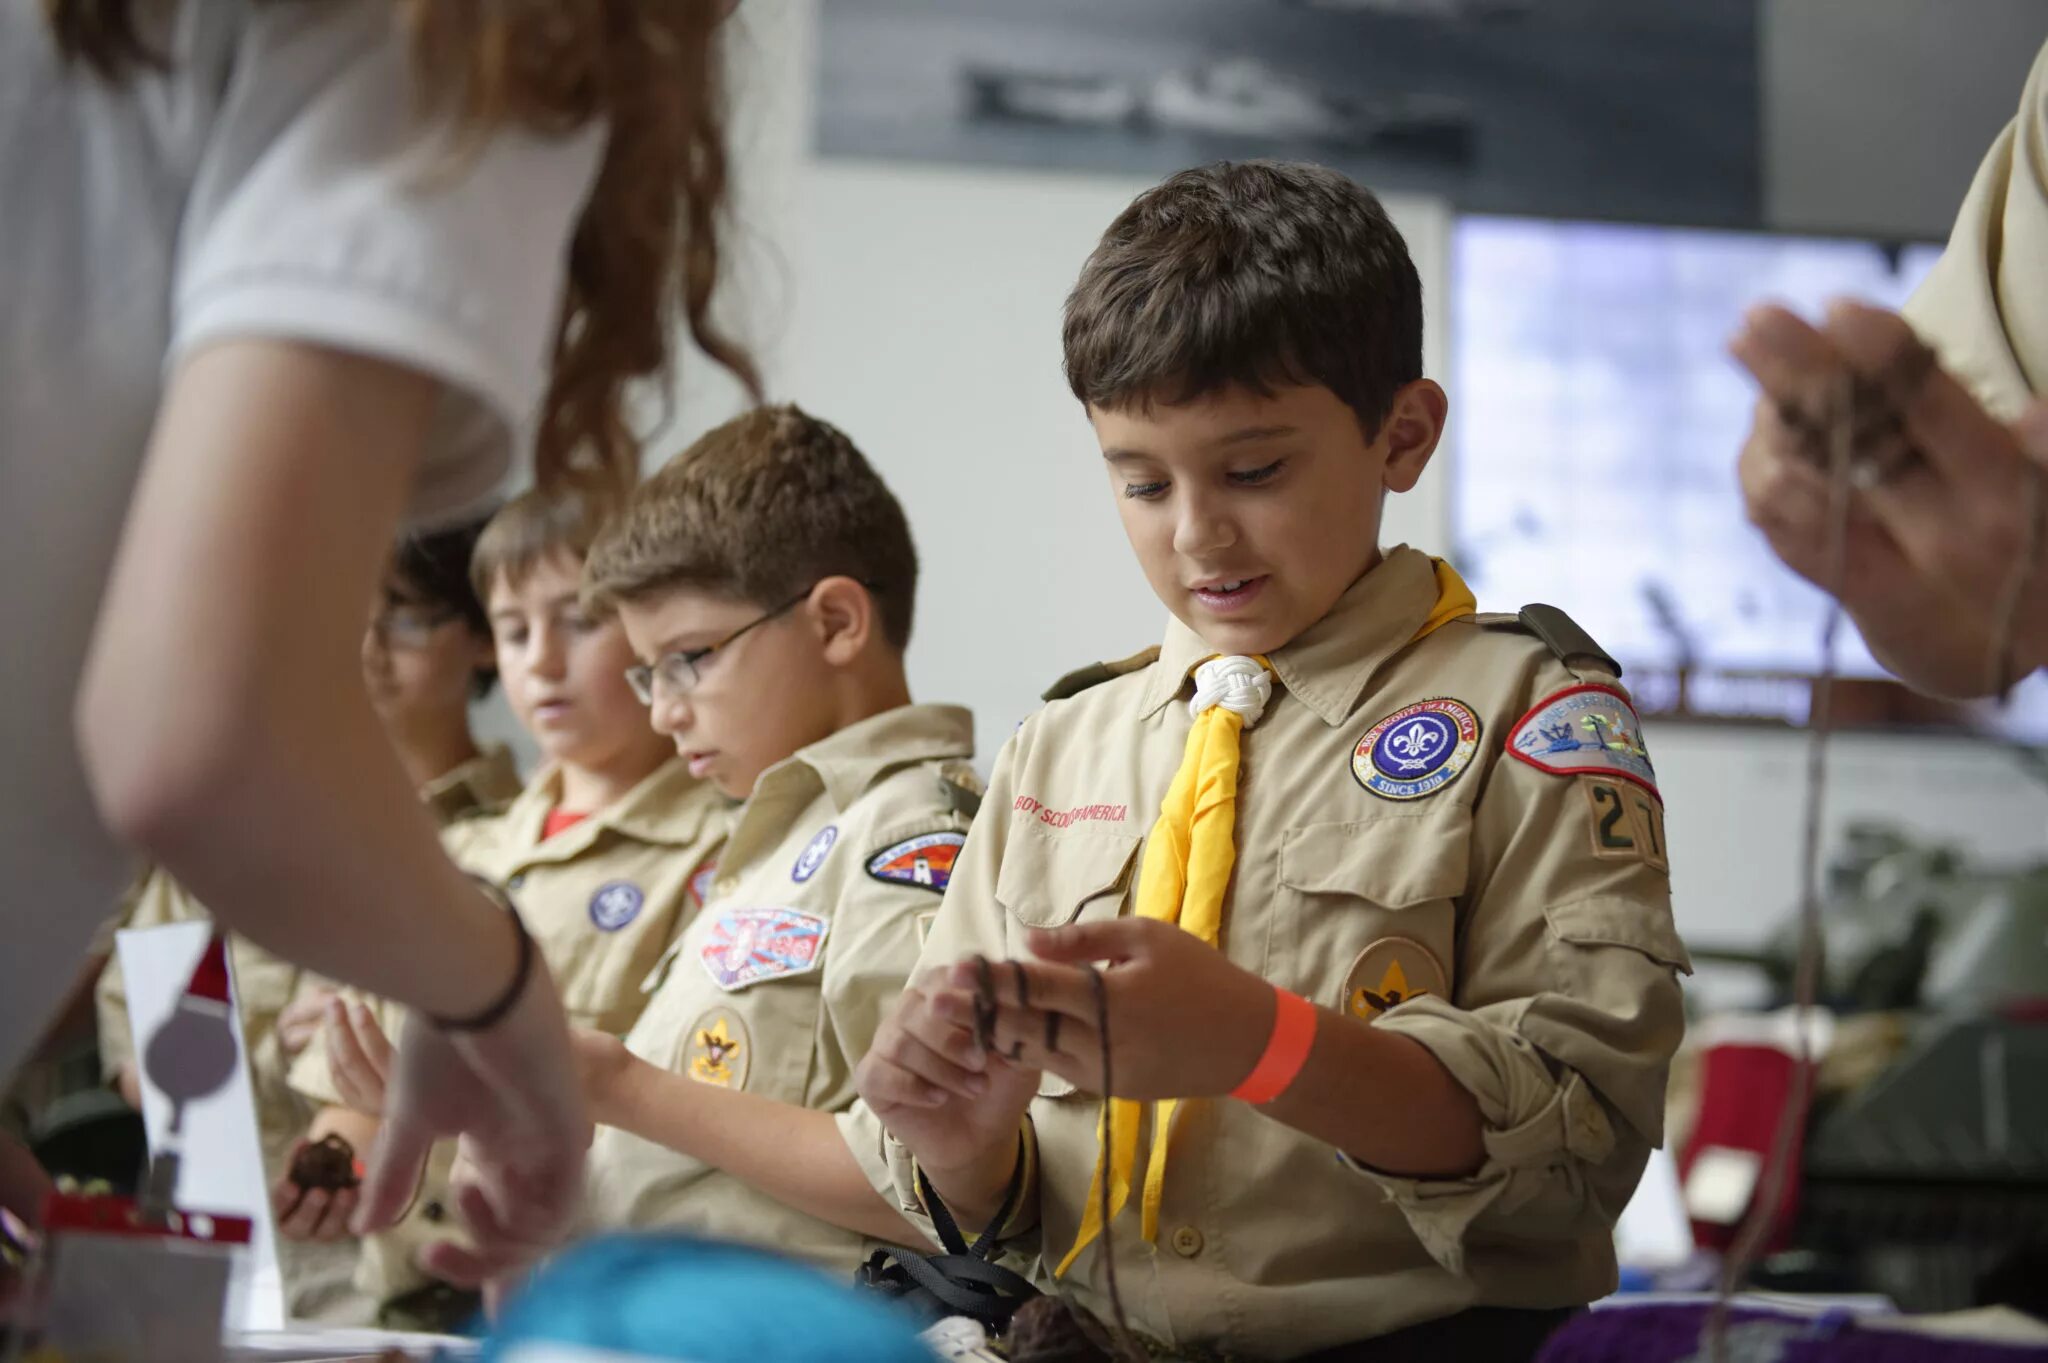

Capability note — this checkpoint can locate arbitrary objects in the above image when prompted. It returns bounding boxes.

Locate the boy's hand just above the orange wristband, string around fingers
[942,919,1274,1099]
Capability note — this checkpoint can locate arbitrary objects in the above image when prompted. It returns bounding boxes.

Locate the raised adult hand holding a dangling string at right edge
[1731,303,2048,696]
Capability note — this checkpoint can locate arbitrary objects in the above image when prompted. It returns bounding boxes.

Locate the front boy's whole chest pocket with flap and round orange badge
[1277,802,1473,1021]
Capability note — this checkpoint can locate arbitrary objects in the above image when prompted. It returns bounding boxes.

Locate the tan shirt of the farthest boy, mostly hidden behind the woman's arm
[94,747,518,1324]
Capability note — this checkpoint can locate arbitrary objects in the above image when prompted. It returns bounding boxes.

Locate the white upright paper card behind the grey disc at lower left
[115,921,285,1332]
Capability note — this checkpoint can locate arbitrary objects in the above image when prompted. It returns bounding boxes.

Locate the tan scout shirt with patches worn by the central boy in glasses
[590,706,979,1273]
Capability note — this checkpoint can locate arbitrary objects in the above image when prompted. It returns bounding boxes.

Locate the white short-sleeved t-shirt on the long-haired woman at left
[0,0,602,1081]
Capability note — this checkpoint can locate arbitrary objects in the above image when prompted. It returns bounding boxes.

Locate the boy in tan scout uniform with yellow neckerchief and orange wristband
[844,162,1688,1363]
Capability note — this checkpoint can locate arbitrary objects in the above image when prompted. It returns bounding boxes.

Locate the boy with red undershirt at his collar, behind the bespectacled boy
[276,491,729,1328]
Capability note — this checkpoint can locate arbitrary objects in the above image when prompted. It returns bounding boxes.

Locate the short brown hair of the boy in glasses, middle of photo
[584,405,918,651]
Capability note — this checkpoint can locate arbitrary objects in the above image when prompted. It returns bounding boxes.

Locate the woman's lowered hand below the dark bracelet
[354,960,590,1287]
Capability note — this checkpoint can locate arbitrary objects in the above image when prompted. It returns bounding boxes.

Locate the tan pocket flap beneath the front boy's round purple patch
[1280,802,1473,909]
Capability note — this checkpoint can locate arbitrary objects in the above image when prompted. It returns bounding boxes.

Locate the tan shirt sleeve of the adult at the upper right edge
[1907,38,2048,422]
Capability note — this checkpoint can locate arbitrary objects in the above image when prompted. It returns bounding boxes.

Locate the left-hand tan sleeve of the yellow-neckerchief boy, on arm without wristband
[840,720,1038,1242]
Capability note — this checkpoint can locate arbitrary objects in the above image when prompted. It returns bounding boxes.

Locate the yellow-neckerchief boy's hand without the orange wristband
[854,964,1038,1170]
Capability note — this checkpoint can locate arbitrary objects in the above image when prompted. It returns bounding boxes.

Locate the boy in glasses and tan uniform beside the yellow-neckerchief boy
[561,407,981,1273]
